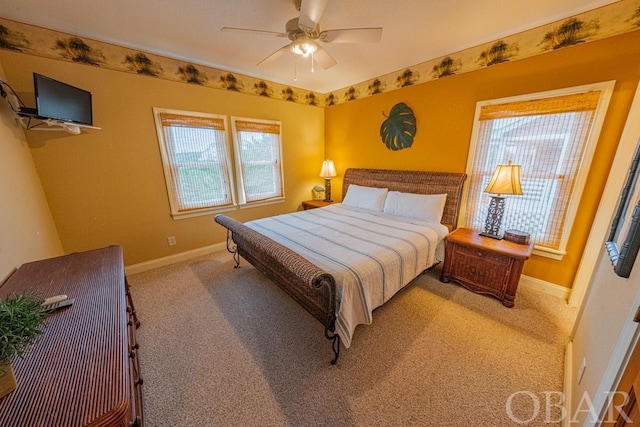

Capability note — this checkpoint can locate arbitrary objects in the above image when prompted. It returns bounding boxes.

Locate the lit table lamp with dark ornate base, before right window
[480,160,522,239]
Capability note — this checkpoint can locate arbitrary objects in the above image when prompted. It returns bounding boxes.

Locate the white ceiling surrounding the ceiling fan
[0,0,616,93]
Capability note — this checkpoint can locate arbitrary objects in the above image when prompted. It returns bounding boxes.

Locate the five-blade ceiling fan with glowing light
[221,0,382,71]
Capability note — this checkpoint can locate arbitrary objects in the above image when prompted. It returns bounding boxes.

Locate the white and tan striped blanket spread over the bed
[245,204,448,347]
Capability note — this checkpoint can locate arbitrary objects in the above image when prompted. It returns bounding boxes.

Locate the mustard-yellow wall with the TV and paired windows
[0,50,324,266]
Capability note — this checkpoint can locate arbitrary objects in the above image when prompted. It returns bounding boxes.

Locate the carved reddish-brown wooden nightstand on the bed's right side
[440,228,533,307]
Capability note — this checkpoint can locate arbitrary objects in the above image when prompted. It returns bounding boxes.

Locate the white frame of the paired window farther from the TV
[231,116,285,209]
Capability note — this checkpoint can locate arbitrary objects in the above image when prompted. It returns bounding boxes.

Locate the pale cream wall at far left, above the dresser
[0,60,63,283]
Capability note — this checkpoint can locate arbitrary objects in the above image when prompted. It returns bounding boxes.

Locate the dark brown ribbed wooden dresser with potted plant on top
[0,246,143,427]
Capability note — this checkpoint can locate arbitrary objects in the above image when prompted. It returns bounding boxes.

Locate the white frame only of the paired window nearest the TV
[153,107,237,220]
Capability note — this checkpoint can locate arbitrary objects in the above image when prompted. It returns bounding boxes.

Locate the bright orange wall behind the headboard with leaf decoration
[325,31,640,287]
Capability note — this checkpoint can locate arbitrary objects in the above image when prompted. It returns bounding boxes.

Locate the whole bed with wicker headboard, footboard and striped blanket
[215,168,466,364]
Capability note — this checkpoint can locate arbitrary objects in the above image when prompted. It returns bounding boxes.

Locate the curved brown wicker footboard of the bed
[215,215,340,364]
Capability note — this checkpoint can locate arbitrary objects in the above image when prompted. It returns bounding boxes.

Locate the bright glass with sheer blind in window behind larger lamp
[475,105,591,249]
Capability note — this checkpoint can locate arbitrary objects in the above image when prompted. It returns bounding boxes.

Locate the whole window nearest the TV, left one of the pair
[153,108,235,219]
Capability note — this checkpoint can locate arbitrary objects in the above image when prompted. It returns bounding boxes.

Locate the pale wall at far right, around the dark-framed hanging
[569,83,640,426]
